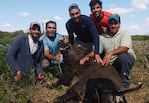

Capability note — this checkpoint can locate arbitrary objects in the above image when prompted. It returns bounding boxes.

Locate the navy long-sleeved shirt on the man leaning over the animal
[66,15,99,53]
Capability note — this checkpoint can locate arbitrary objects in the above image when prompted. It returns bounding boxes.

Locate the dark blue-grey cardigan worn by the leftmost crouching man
[6,35,43,76]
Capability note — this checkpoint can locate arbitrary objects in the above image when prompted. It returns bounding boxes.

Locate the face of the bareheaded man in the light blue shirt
[46,23,56,37]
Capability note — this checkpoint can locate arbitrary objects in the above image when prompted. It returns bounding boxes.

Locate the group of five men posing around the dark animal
[6,0,135,88]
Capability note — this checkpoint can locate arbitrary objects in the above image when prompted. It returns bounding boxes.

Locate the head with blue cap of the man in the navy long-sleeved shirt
[69,3,81,22]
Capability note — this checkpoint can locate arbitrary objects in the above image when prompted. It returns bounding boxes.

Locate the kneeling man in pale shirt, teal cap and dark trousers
[80,14,136,88]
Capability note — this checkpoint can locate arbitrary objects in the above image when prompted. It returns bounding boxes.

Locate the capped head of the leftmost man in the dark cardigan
[29,22,41,41]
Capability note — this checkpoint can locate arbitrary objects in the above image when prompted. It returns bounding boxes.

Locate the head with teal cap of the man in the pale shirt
[108,14,121,35]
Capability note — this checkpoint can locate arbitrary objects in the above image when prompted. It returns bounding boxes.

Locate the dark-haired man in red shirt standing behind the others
[89,0,112,34]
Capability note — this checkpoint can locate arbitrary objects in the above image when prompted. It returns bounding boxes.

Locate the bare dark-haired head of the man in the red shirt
[89,0,102,18]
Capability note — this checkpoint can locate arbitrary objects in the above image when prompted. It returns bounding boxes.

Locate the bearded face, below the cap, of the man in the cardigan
[30,28,41,40]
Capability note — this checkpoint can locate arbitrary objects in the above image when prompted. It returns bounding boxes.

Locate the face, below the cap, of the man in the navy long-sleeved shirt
[69,8,81,22]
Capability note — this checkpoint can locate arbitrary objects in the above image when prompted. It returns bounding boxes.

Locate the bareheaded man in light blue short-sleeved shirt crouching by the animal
[40,21,68,68]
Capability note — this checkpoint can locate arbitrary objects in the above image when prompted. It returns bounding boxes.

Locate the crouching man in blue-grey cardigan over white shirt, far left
[6,22,44,81]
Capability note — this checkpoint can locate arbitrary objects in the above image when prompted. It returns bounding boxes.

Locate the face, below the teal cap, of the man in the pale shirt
[108,19,120,35]
